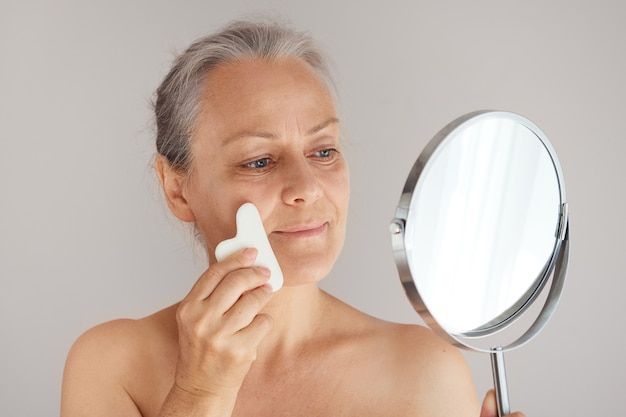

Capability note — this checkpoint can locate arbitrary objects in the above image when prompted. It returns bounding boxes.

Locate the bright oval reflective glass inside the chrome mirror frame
[406,117,561,333]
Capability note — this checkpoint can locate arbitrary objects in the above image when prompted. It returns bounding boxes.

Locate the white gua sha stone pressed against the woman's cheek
[215,203,283,292]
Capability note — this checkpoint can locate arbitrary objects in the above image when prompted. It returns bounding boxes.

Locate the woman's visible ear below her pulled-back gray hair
[155,155,196,223]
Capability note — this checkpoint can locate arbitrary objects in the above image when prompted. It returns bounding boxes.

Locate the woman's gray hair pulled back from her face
[154,21,336,172]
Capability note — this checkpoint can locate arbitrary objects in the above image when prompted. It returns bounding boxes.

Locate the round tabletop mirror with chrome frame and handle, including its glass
[390,111,569,415]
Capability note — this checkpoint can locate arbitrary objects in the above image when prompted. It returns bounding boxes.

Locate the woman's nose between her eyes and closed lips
[282,157,322,205]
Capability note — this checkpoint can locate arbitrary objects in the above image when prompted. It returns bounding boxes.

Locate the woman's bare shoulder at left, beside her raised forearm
[61,304,178,417]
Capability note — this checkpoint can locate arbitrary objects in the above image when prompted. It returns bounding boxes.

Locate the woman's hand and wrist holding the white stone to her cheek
[169,248,272,405]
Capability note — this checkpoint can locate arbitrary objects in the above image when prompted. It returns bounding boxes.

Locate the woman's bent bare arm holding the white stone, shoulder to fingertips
[61,250,271,417]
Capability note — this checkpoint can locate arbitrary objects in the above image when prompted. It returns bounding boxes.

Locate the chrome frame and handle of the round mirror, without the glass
[389,110,569,415]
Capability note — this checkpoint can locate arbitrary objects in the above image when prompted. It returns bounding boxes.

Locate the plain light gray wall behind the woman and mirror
[0,0,626,417]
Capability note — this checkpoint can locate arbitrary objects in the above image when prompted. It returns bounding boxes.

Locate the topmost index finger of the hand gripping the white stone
[185,248,258,300]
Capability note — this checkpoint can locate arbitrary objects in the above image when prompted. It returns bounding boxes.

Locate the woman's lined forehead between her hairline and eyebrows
[196,57,336,141]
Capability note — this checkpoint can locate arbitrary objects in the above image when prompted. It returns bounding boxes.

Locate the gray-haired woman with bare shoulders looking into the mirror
[61,22,520,417]
